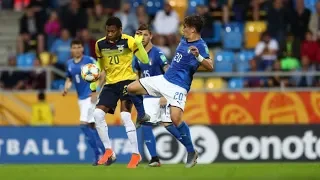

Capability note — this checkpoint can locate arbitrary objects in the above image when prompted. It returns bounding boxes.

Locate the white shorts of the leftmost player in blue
[78,97,95,123]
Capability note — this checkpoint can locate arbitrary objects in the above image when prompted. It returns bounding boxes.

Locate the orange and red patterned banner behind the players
[0,92,320,125]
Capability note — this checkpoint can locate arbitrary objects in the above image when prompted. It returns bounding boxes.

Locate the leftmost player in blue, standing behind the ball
[62,40,105,165]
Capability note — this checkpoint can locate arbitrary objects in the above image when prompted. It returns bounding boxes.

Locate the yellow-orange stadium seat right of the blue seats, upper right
[245,21,267,49]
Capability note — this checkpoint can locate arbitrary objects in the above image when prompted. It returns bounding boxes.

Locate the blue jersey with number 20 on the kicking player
[164,38,210,91]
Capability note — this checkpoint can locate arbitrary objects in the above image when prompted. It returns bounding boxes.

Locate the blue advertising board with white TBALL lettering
[0,126,142,163]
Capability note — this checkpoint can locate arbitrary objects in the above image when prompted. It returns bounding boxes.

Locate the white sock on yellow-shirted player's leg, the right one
[120,112,139,154]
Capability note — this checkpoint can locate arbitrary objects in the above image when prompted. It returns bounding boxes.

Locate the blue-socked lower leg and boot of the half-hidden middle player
[142,125,161,167]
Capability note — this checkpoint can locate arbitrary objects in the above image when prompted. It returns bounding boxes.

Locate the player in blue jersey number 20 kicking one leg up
[127,15,213,168]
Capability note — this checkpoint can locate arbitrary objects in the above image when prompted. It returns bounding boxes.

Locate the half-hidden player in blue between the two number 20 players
[133,24,192,167]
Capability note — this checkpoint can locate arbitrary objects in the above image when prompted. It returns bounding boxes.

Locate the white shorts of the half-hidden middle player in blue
[143,97,172,124]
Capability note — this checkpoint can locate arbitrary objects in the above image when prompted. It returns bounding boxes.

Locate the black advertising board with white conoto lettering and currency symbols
[144,125,320,164]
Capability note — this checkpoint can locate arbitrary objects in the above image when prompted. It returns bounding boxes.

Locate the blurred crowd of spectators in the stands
[0,0,320,90]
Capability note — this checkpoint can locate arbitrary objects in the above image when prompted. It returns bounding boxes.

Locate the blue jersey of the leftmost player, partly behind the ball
[67,56,95,99]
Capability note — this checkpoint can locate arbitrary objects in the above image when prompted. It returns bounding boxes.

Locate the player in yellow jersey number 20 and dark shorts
[91,17,149,168]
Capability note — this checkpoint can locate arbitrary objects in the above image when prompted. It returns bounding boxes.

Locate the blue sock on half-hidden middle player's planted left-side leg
[142,125,158,157]
